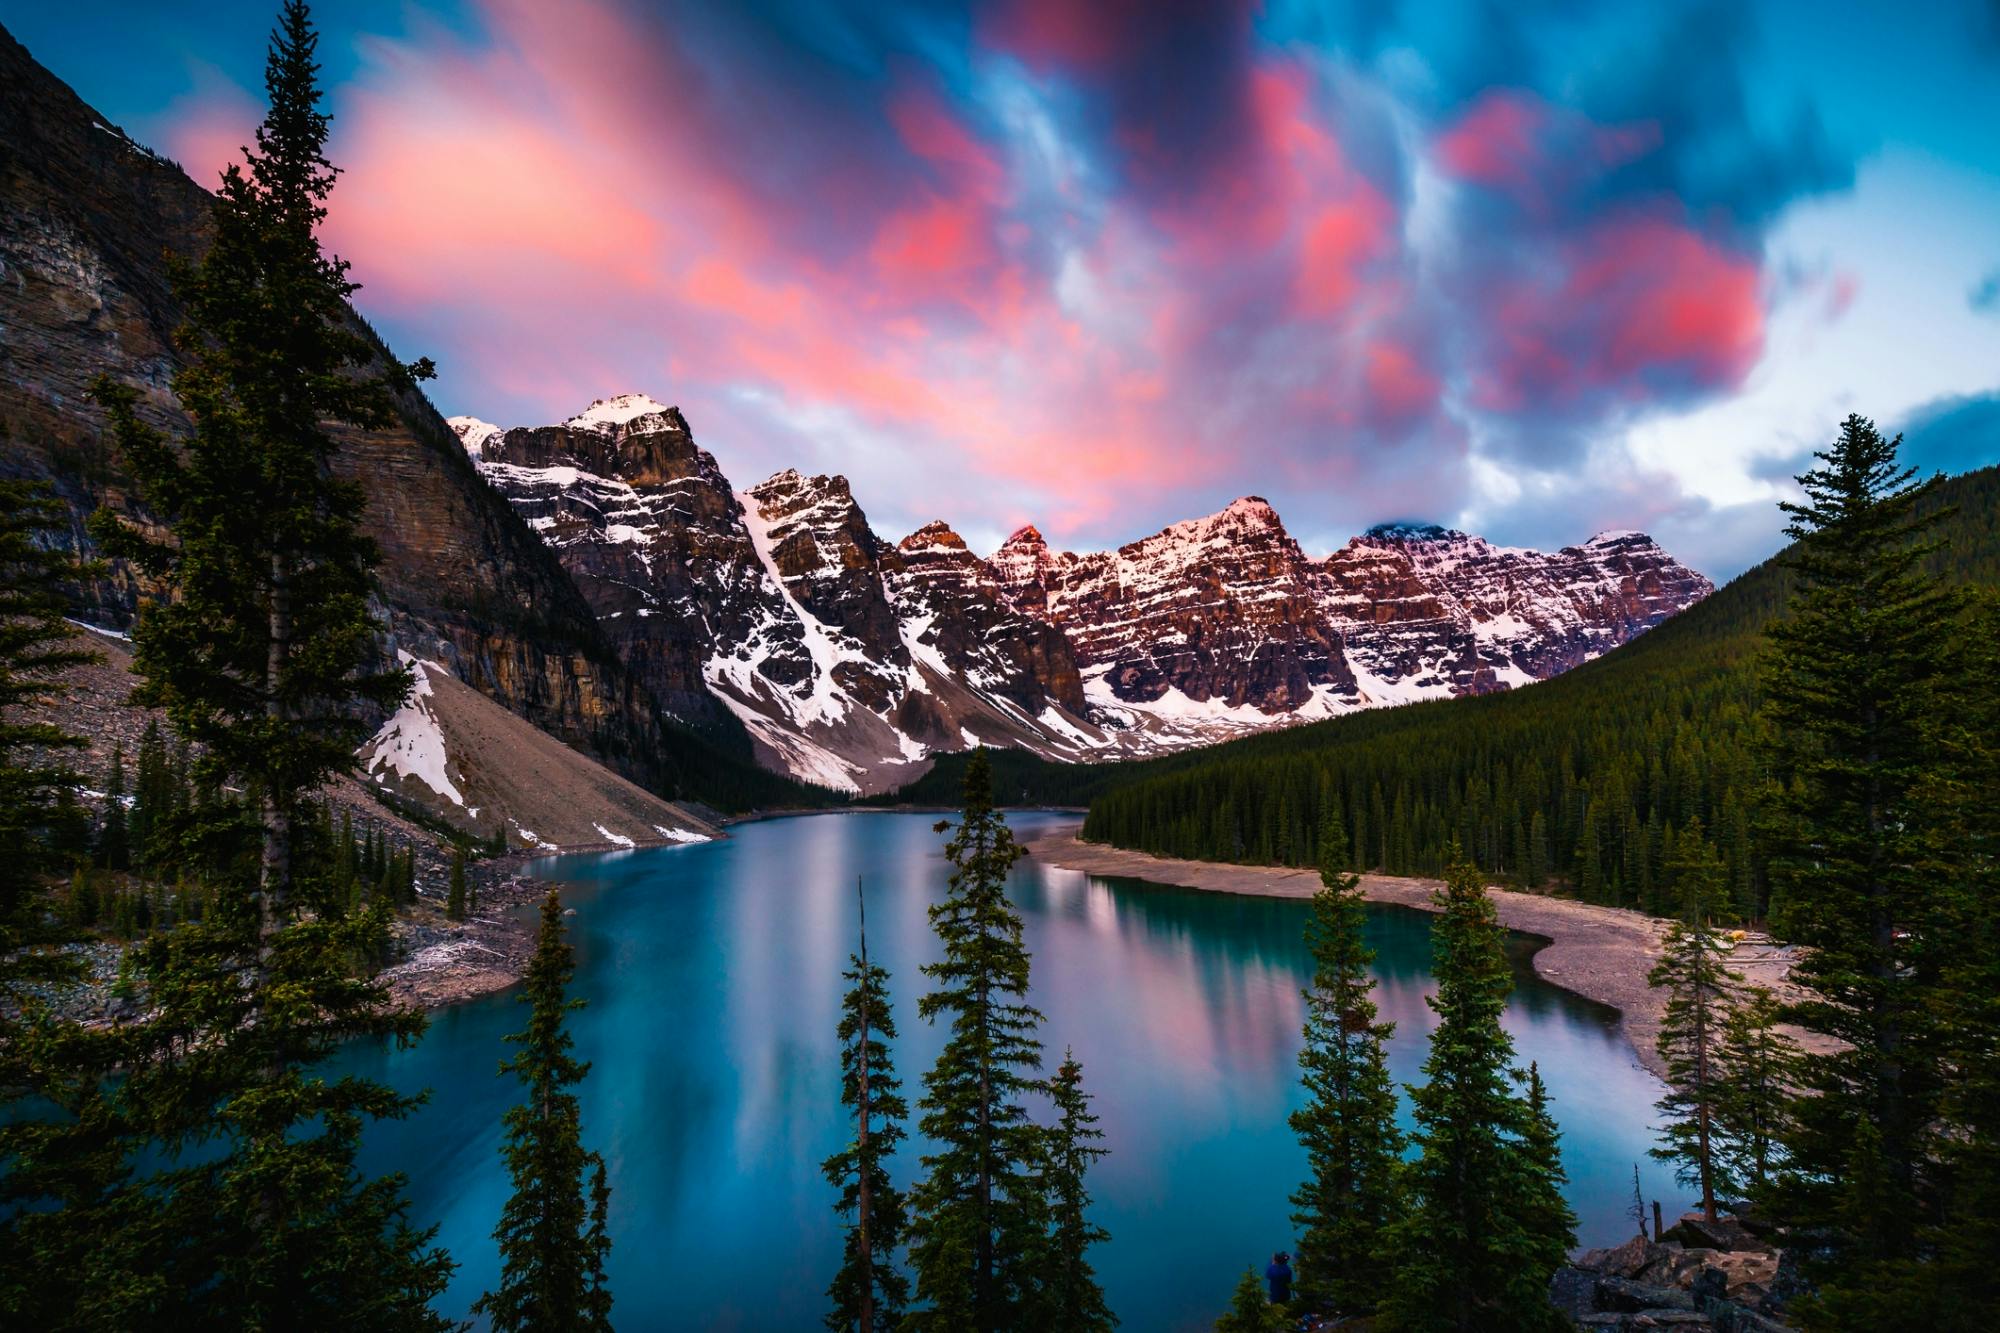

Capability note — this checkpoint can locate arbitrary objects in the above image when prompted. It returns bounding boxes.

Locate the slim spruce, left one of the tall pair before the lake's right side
[1292,817,1404,1315]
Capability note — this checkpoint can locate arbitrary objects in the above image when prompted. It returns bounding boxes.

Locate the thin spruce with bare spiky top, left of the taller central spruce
[822,885,910,1333]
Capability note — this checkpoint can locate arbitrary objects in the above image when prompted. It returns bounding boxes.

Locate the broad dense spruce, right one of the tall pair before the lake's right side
[1378,845,1572,1333]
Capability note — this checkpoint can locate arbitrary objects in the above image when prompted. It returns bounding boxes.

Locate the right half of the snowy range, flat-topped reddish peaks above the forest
[992,506,1712,733]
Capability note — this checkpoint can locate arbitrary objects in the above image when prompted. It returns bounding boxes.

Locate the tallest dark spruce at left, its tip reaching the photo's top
[92,0,424,963]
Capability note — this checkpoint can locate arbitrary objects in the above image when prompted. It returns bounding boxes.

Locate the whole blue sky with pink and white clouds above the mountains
[27,0,2000,576]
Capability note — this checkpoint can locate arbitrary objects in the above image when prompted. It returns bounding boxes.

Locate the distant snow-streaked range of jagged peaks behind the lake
[450,394,1712,793]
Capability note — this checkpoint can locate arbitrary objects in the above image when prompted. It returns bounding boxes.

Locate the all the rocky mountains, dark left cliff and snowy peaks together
[0,30,1710,809]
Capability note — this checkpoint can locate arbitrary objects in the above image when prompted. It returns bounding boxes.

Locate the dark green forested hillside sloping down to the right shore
[902,468,2000,915]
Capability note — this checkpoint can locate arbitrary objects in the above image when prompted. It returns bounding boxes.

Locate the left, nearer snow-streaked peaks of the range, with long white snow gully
[452,404,1104,791]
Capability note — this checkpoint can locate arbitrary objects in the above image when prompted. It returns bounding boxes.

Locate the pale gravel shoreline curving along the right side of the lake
[1026,829,1824,1079]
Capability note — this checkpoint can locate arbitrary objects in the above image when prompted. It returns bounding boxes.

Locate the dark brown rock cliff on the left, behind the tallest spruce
[0,30,680,779]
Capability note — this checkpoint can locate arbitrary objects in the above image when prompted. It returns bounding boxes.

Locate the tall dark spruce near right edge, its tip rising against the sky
[1762,416,1968,1304]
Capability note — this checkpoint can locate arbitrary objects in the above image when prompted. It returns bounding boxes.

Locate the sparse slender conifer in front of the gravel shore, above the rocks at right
[1646,819,1740,1221]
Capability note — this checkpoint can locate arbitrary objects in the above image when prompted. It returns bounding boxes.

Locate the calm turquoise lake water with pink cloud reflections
[336,815,1680,1329]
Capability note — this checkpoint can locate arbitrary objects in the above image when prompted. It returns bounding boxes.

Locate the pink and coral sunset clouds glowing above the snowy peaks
[148,0,1762,540]
